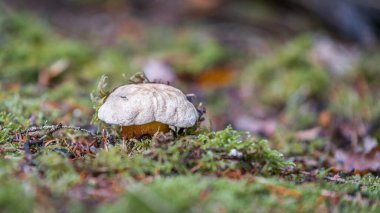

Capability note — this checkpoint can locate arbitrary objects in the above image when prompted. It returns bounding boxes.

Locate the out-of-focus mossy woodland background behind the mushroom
[0,0,380,171]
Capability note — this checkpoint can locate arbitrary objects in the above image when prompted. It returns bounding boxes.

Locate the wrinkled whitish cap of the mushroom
[98,83,198,128]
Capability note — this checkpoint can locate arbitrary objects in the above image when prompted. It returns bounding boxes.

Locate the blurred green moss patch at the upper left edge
[0,11,90,82]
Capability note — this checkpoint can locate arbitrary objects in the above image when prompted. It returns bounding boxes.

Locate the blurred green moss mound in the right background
[242,36,329,105]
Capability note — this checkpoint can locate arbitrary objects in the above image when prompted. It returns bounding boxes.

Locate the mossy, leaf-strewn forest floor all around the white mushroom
[0,1,380,212]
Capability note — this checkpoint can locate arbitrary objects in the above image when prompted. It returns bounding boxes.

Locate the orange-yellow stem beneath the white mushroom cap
[121,121,170,139]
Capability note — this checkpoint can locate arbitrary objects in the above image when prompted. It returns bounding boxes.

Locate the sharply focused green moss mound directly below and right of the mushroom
[81,127,294,176]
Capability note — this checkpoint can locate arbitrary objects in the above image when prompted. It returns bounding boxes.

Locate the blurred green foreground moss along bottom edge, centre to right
[99,176,379,212]
